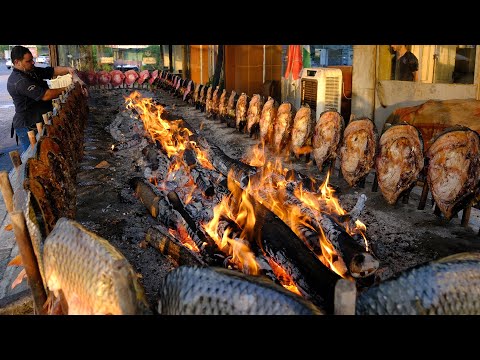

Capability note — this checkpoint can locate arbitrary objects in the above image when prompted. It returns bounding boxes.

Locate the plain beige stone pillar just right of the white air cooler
[352,45,377,120]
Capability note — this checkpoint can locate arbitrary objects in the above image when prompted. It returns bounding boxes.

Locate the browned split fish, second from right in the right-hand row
[375,124,424,205]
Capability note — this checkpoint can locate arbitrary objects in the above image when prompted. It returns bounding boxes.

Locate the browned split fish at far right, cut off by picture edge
[426,126,480,219]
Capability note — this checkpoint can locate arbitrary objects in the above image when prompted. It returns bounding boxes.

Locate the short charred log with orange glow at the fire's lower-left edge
[145,226,207,266]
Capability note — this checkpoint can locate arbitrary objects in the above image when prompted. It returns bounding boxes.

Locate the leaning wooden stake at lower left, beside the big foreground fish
[10,211,47,315]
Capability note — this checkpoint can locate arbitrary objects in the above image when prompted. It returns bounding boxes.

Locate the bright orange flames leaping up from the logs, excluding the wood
[125,91,368,292]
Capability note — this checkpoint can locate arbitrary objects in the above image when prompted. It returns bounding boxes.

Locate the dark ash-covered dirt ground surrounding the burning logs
[76,89,480,314]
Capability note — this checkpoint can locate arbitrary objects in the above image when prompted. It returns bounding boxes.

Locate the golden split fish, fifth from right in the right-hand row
[291,105,314,155]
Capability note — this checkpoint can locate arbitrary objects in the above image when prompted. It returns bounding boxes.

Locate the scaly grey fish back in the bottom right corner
[356,253,480,315]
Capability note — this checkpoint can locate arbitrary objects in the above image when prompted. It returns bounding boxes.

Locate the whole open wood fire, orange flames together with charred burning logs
[125,92,378,306]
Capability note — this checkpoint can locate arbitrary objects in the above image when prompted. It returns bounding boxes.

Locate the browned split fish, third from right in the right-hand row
[340,118,378,186]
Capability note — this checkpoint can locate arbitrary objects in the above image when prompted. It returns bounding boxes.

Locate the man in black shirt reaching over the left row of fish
[7,45,81,151]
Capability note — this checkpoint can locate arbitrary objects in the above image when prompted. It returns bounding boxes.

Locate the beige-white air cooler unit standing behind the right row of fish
[300,68,343,120]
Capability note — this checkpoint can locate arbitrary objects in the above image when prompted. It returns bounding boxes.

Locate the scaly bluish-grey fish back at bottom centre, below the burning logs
[158,266,323,315]
